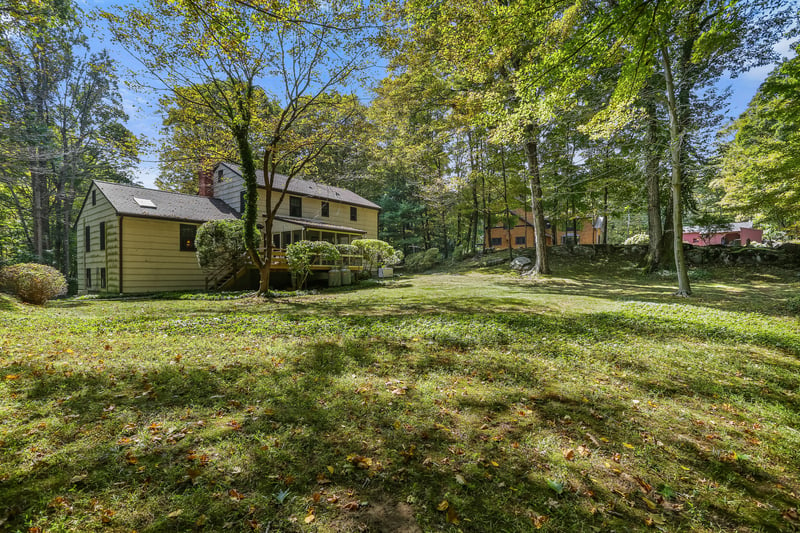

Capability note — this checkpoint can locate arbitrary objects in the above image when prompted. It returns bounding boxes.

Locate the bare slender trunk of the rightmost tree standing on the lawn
[661,43,692,297]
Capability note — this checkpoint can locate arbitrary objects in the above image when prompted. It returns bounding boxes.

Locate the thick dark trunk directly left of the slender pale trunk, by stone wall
[644,84,664,272]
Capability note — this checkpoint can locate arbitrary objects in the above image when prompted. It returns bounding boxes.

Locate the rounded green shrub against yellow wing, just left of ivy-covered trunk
[195,219,247,273]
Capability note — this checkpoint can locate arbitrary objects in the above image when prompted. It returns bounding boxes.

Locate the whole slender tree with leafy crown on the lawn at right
[579,0,788,296]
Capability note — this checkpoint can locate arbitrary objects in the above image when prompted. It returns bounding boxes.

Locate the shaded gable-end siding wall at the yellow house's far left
[75,185,120,294]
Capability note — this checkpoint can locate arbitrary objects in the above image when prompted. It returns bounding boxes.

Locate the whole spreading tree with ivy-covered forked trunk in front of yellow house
[104,0,376,294]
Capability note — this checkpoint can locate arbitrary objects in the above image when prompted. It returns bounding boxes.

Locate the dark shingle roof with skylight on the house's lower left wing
[87,180,238,223]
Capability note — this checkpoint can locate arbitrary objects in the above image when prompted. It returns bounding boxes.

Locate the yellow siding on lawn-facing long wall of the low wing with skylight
[122,217,205,293]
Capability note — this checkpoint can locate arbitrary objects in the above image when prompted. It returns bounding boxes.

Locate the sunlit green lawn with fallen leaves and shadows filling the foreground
[0,263,800,532]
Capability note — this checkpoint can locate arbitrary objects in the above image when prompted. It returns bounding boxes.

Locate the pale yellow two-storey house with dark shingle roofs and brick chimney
[75,163,380,294]
